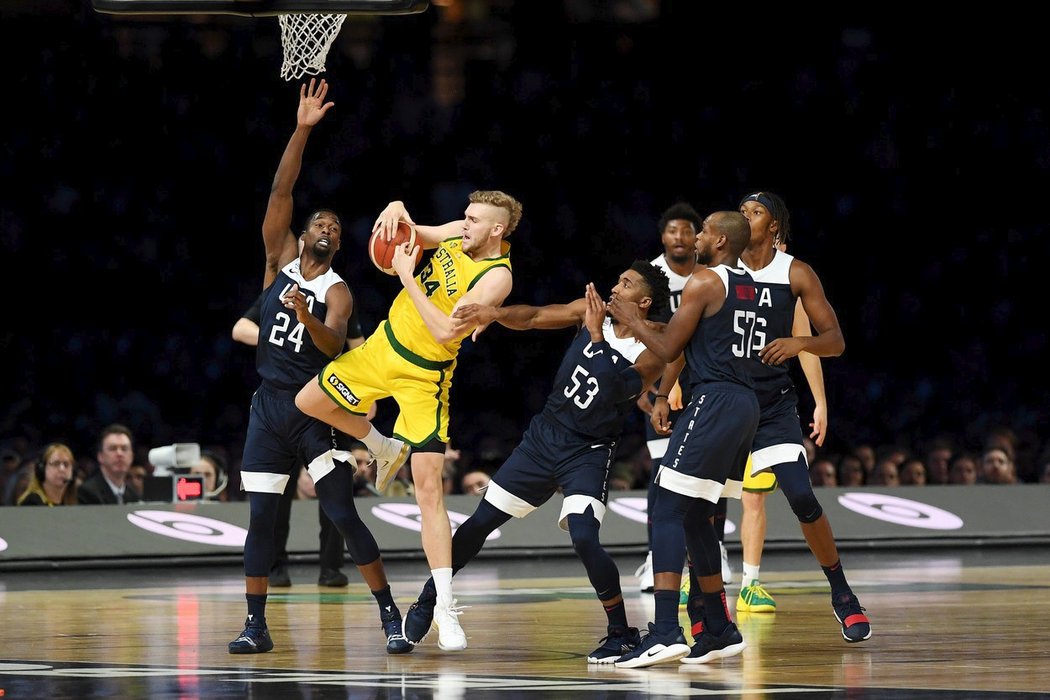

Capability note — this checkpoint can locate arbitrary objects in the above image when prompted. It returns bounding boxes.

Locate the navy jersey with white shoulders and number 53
[542,318,645,442]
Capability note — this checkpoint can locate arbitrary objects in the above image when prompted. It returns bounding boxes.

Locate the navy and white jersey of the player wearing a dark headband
[740,250,798,396]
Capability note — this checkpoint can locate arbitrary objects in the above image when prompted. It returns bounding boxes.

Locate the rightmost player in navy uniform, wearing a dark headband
[740,192,872,642]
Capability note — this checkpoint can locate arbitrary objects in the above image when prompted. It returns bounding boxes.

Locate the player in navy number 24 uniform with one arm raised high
[229,79,412,654]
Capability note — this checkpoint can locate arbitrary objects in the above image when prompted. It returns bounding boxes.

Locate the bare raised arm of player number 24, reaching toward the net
[263,78,335,289]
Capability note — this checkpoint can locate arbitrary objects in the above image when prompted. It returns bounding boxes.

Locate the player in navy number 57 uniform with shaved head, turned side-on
[609,211,762,669]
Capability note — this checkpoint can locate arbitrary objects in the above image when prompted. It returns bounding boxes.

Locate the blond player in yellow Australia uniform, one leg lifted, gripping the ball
[295,191,522,651]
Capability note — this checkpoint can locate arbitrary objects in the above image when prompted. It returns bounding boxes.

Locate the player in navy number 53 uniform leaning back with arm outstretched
[394,260,668,663]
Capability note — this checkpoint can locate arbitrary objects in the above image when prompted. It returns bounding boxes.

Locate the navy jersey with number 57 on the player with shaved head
[686,264,762,397]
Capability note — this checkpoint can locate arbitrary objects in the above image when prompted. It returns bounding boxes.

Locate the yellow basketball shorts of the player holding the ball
[320,322,456,447]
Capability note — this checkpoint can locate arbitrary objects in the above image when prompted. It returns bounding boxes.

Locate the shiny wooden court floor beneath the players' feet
[0,546,1050,700]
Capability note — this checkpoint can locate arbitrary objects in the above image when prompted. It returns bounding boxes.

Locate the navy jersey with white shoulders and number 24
[255,258,347,393]
